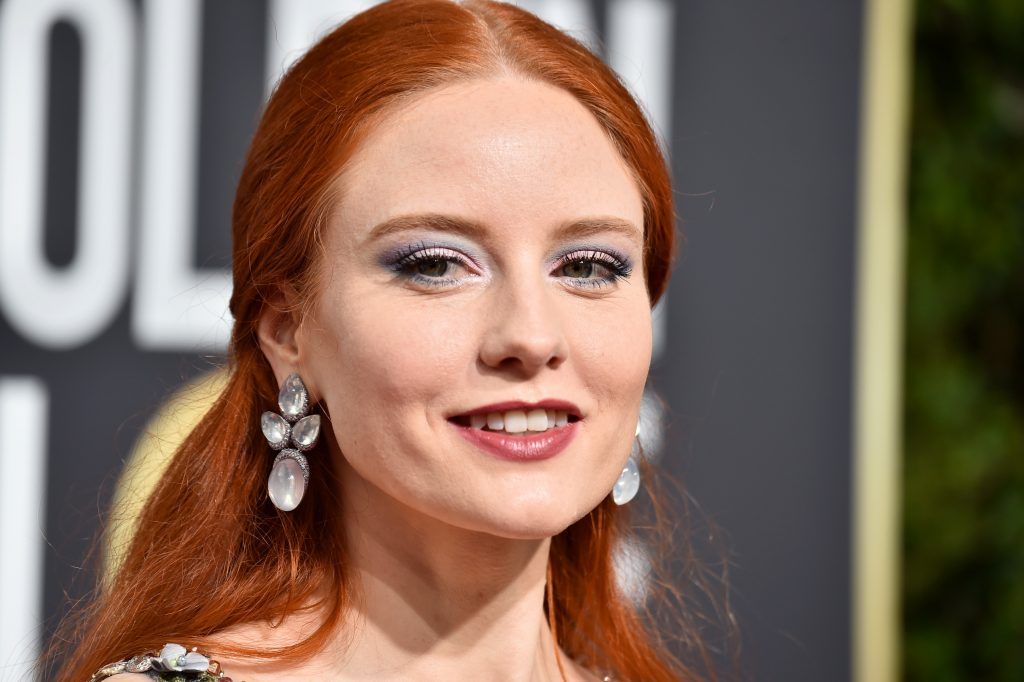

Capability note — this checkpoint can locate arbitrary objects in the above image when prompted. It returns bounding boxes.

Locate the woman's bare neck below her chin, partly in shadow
[337,456,568,682]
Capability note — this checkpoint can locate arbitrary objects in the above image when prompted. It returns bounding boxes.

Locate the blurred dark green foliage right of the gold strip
[903,0,1024,682]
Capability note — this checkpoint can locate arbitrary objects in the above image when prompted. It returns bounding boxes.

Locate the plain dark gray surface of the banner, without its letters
[0,0,863,681]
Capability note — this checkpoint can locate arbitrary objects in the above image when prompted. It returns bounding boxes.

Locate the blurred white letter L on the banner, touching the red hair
[132,0,231,350]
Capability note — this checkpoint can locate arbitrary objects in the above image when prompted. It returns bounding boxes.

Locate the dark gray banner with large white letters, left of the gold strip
[0,0,864,681]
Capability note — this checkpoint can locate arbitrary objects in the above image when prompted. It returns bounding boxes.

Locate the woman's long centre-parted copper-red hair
[54,0,737,682]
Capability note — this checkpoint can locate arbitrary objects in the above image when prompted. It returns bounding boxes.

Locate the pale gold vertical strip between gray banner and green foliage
[852,0,912,682]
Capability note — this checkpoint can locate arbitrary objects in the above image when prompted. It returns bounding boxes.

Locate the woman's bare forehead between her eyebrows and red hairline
[338,78,643,238]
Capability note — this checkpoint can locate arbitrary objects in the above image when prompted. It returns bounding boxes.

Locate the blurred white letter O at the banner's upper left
[0,0,135,349]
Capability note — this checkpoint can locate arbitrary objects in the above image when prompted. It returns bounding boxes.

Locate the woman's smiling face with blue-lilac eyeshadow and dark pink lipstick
[297,79,651,538]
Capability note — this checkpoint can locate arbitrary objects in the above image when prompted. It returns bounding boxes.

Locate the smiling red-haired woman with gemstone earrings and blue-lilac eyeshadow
[51,0,724,682]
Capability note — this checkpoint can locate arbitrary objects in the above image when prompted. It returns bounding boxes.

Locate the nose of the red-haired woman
[480,280,571,376]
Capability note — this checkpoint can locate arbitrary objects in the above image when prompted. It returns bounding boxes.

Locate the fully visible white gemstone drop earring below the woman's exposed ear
[260,374,319,511]
